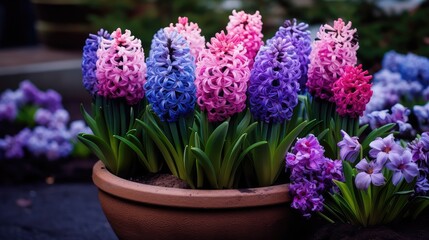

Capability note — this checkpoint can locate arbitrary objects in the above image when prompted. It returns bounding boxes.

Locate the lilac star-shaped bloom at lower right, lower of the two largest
[386,150,419,186]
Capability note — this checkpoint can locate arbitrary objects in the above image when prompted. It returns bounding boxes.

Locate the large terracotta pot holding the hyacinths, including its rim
[93,162,302,240]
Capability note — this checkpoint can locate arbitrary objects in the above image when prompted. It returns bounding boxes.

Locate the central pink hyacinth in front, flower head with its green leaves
[190,32,264,188]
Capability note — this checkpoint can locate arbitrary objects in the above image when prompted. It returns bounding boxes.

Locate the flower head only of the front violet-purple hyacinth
[248,36,301,123]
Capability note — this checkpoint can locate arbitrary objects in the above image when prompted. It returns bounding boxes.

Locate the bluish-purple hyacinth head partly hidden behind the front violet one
[273,18,312,91]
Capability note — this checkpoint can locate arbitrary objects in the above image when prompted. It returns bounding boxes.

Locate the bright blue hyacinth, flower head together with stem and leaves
[132,29,197,182]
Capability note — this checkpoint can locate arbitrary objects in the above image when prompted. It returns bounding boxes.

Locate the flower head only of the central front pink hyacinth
[195,31,250,122]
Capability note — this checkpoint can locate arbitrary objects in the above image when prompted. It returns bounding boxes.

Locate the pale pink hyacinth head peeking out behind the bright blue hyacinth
[166,17,205,62]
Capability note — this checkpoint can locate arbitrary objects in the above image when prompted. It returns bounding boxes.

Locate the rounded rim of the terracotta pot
[92,161,290,209]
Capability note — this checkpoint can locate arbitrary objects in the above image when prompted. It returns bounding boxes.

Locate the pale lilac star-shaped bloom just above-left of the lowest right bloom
[369,134,404,165]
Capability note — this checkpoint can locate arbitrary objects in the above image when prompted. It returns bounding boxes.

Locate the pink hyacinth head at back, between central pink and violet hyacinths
[226,10,264,69]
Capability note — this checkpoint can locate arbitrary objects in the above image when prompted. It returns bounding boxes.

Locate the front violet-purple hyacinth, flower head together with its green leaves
[248,36,308,186]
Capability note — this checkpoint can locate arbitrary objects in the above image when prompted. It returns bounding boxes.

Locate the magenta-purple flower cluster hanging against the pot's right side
[286,134,344,218]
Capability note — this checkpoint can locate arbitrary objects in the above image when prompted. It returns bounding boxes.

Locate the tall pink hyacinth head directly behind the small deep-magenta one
[307,18,359,102]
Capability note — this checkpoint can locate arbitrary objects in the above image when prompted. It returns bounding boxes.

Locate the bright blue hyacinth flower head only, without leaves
[144,29,196,122]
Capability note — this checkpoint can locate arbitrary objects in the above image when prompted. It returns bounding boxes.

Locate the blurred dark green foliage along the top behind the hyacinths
[88,0,429,72]
